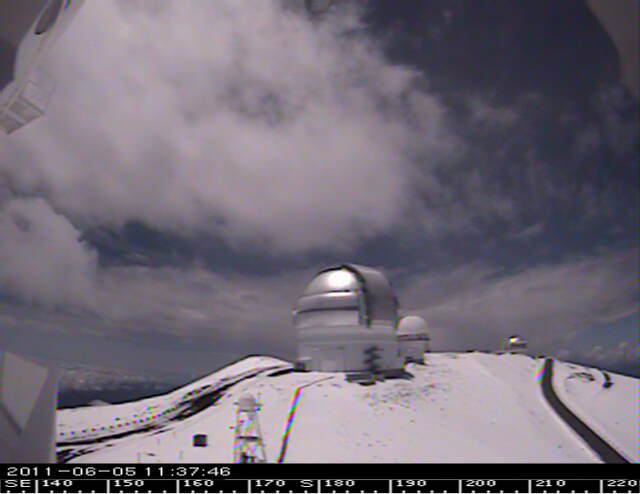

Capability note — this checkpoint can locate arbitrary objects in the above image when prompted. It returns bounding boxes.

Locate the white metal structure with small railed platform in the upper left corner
[0,0,84,134]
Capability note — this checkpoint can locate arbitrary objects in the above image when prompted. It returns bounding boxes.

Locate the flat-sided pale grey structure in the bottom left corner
[0,350,57,463]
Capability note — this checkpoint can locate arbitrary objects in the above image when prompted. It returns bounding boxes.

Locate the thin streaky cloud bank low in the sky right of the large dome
[401,251,638,351]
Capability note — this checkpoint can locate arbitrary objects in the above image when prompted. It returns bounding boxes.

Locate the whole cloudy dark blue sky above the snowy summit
[0,0,639,394]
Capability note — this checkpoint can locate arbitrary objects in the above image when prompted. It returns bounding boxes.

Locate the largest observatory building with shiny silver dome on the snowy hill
[293,264,402,374]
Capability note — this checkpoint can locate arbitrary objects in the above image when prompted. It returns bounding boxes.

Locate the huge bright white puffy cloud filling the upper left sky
[0,0,458,251]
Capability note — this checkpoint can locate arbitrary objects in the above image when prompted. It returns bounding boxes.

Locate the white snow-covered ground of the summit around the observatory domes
[58,352,637,463]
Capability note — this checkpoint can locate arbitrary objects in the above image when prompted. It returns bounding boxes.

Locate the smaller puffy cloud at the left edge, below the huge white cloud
[0,198,96,307]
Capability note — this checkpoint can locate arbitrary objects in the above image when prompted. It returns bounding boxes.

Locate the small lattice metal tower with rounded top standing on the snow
[233,394,267,463]
